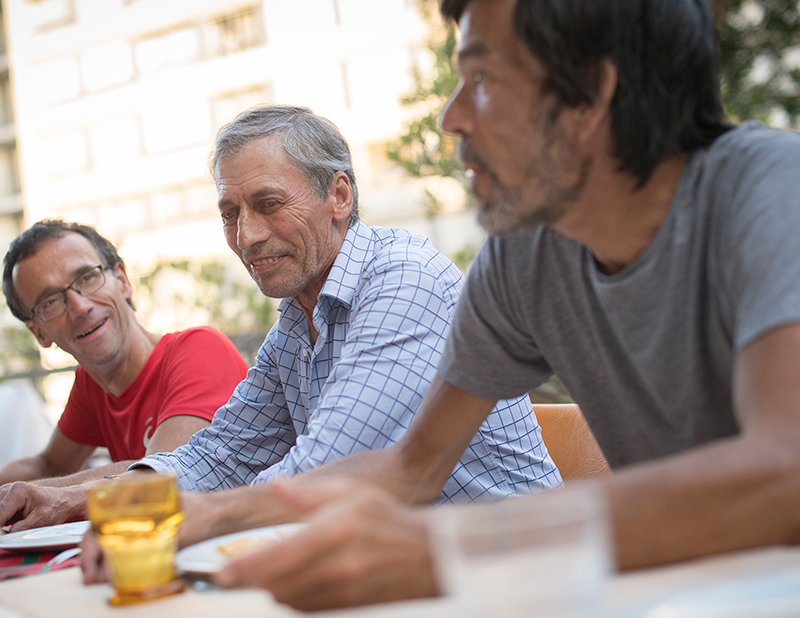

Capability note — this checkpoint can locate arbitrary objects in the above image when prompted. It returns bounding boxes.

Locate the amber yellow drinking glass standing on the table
[86,473,184,605]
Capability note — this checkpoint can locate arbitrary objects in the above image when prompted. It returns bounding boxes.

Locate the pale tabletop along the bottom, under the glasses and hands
[0,546,800,618]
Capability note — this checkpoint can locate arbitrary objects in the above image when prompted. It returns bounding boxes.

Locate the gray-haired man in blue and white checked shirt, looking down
[23,106,561,544]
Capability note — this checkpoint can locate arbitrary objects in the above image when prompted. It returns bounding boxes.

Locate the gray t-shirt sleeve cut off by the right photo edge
[717,131,800,350]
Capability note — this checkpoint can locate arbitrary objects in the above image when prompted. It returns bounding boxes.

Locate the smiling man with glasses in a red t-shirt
[0,220,247,499]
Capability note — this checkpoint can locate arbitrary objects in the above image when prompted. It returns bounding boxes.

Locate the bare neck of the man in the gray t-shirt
[553,155,686,274]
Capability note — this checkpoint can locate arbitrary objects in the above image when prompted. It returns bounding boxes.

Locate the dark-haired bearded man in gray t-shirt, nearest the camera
[178,0,800,609]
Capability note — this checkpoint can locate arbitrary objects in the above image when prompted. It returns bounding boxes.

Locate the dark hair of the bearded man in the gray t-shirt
[439,0,732,186]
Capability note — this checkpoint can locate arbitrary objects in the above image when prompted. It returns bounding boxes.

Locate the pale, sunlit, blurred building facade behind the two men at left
[0,0,478,269]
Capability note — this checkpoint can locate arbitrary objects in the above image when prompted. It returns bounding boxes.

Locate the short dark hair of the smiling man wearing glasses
[3,219,126,322]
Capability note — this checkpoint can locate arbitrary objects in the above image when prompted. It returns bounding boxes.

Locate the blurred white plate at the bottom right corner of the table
[646,568,800,618]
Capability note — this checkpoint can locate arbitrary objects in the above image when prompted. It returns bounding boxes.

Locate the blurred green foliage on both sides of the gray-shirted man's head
[386,0,800,196]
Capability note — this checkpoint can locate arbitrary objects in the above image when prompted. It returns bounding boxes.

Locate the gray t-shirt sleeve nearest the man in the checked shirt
[439,237,552,399]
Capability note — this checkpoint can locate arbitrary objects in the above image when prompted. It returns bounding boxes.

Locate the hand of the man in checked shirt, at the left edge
[0,482,86,532]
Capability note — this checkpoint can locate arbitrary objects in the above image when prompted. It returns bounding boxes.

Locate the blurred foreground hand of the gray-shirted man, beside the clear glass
[216,482,437,610]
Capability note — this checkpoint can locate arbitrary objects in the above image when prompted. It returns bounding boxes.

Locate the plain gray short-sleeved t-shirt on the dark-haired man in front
[439,123,800,467]
